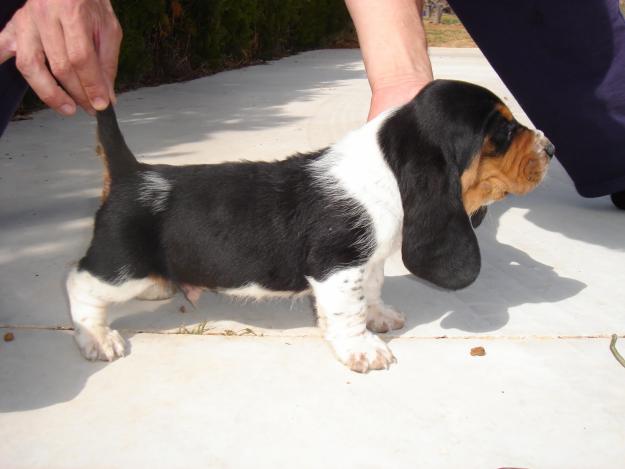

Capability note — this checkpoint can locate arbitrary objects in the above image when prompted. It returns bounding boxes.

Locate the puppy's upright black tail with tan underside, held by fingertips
[96,105,139,191]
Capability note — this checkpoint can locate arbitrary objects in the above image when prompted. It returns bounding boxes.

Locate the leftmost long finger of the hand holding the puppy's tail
[11,9,76,115]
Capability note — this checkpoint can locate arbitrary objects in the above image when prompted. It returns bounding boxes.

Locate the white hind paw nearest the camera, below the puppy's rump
[74,326,126,362]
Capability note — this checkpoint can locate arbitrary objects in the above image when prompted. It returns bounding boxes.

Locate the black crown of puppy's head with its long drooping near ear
[378,80,498,290]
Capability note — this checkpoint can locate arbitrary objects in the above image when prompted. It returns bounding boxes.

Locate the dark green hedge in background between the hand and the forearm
[112,0,351,88]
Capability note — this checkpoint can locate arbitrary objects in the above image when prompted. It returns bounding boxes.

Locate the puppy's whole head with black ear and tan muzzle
[379,80,554,289]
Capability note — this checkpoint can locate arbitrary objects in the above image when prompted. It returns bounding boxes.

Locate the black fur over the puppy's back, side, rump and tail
[79,112,374,291]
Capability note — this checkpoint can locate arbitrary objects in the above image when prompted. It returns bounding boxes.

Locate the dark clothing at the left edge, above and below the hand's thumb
[0,0,28,137]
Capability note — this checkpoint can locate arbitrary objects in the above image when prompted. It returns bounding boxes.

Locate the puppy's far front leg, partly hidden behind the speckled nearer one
[365,262,406,333]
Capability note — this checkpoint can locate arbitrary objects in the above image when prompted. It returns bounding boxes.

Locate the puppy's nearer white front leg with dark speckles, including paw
[309,267,395,373]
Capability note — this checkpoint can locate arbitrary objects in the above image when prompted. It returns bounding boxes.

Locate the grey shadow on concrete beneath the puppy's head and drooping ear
[383,196,586,336]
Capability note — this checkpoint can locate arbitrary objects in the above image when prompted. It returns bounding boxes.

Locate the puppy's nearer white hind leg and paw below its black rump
[67,268,154,361]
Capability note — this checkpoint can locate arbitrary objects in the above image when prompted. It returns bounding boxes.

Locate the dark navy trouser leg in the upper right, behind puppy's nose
[449,0,625,197]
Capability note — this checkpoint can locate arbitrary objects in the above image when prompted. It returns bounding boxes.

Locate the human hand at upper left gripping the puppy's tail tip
[0,0,122,115]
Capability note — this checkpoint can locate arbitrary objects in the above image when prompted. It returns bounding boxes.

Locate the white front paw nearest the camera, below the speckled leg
[331,332,396,373]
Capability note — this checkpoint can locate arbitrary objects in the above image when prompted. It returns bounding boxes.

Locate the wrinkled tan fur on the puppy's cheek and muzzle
[461,122,549,214]
